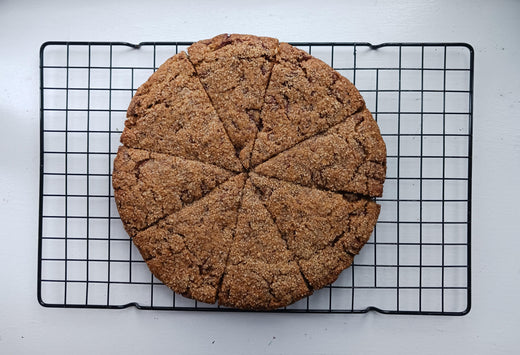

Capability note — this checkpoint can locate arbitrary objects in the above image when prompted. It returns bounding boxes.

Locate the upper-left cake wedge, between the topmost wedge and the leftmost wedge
[121,52,242,171]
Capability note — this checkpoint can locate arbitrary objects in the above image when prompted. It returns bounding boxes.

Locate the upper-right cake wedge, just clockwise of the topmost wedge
[251,43,365,166]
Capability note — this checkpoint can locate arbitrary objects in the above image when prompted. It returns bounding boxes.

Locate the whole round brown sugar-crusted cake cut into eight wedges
[112,34,386,310]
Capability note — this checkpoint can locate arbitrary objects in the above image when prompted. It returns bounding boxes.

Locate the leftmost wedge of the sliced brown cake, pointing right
[112,146,234,235]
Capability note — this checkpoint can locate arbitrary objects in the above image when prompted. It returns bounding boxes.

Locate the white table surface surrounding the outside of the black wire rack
[0,0,520,354]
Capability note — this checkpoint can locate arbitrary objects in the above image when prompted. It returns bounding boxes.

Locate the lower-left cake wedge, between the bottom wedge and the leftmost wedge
[133,174,245,303]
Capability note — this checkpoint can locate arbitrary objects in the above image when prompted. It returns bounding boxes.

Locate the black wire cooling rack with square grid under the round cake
[38,42,474,315]
